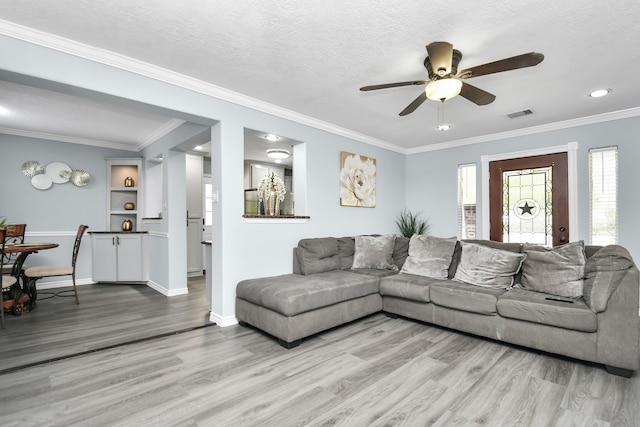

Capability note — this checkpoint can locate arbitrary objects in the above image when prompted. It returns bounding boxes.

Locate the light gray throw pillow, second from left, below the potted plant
[400,234,458,279]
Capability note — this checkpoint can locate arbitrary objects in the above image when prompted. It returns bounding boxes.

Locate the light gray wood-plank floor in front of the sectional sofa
[0,280,640,426]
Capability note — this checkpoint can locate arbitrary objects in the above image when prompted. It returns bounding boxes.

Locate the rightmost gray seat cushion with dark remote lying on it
[498,289,598,332]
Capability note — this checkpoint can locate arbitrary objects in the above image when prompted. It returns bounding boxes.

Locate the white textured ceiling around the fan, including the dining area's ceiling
[0,0,640,152]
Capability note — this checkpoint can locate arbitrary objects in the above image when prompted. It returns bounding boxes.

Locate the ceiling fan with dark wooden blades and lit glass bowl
[360,42,544,116]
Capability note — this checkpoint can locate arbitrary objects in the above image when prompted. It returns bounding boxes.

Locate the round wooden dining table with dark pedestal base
[2,242,58,315]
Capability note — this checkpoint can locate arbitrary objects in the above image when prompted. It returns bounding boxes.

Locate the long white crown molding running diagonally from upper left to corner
[0,19,406,154]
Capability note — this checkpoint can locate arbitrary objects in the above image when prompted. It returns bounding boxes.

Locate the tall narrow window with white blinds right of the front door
[589,147,618,245]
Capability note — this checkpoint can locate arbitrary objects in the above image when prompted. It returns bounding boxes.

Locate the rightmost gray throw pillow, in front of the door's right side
[520,241,587,298]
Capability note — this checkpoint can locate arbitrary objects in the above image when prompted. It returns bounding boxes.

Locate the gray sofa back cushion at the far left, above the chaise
[296,237,340,275]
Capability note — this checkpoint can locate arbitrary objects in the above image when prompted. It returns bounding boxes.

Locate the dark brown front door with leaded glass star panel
[489,153,569,246]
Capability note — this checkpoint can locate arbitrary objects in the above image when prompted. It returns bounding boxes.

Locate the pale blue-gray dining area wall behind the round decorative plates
[0,134,137,283]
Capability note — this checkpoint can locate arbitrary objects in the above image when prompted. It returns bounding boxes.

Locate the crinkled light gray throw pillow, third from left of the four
[454,242,525,289]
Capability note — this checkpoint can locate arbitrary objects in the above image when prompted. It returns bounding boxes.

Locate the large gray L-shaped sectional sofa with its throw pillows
[236,235,640,376]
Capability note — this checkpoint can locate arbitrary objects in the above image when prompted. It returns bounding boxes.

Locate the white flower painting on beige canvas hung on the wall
[340,151,376,208]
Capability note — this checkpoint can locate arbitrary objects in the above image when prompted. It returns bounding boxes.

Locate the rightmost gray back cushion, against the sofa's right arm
[584,245,633,313]
